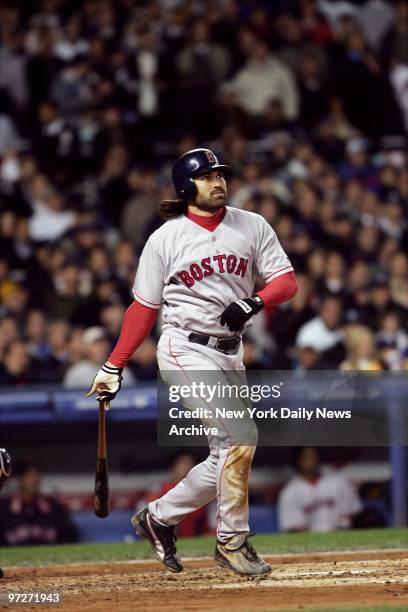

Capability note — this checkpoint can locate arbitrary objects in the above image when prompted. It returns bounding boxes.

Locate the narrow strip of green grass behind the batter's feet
[0,529,408,567]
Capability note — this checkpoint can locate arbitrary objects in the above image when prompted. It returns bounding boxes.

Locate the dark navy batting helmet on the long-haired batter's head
[172,149,230,202]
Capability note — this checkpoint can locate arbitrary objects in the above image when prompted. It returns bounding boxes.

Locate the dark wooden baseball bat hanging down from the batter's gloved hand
[95,401,109,518]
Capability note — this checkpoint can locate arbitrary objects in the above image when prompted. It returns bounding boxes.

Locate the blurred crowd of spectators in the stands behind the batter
[0,0,408,388]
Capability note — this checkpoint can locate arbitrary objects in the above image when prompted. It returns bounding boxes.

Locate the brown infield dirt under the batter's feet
[0,551,408,612]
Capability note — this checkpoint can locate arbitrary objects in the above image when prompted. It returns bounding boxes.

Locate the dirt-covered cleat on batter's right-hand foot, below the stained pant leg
[214,534,272,576]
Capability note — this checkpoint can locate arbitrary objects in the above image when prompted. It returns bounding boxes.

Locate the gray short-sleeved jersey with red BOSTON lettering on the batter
[133,206,293,337]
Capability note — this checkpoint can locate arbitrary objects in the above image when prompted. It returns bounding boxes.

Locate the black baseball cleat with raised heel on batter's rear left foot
[131,508,184,572]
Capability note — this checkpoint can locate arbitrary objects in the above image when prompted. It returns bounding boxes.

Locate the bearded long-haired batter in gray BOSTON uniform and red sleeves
[88,149,297,575]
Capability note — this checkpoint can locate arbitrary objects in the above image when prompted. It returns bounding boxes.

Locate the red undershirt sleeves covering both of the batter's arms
[108,272,297,368]
